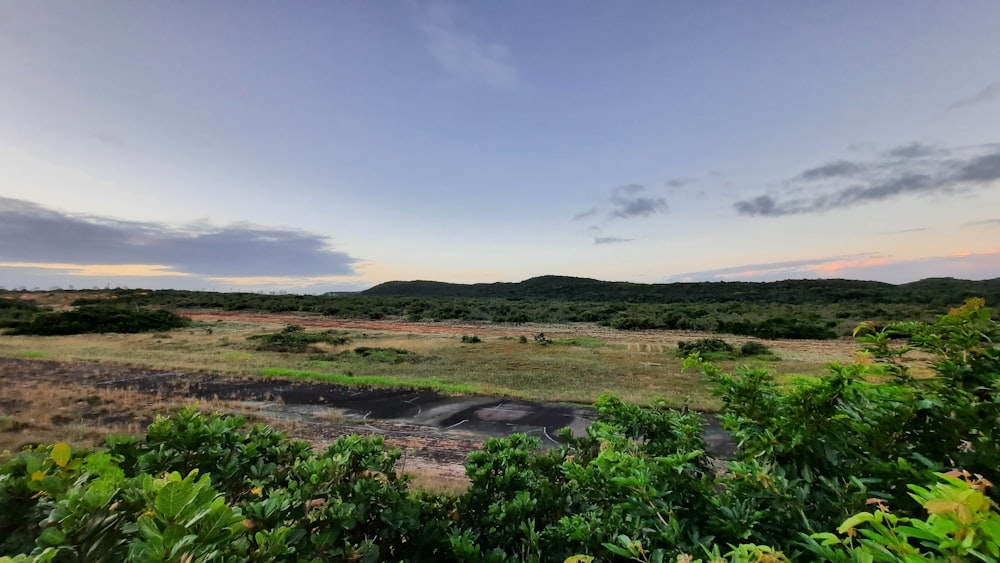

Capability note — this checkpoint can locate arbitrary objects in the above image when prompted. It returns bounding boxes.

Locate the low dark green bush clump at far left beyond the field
[9,305,191,336]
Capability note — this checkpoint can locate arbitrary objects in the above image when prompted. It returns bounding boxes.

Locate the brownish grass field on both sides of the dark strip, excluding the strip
[0,310,857,489]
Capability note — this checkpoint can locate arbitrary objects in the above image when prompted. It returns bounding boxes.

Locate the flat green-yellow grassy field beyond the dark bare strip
[0,322,857,410]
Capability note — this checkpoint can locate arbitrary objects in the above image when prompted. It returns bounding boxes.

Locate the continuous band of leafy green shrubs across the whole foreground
[0,300,1000,562]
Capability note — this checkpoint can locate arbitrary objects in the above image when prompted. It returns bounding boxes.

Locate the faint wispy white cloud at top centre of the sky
[420,2,520,89]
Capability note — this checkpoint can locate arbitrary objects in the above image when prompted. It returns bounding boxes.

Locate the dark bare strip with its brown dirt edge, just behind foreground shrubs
[0,358,732,486]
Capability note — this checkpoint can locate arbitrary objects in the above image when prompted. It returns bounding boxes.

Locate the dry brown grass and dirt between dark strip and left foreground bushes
[0,358,484,478]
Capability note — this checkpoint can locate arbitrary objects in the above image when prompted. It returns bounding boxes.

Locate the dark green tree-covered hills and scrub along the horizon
[0,276,1000,339]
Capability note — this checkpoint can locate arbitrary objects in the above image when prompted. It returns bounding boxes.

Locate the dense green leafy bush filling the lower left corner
[0,409,446,561]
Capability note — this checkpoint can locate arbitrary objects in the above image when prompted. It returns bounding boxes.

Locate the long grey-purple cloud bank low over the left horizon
[0,197,357,278]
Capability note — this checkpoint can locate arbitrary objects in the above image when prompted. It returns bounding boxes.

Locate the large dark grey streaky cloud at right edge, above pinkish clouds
[734,144,1000,217]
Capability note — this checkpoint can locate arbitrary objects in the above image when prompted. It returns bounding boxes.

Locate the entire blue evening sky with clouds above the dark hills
[0,0,1000,293]
